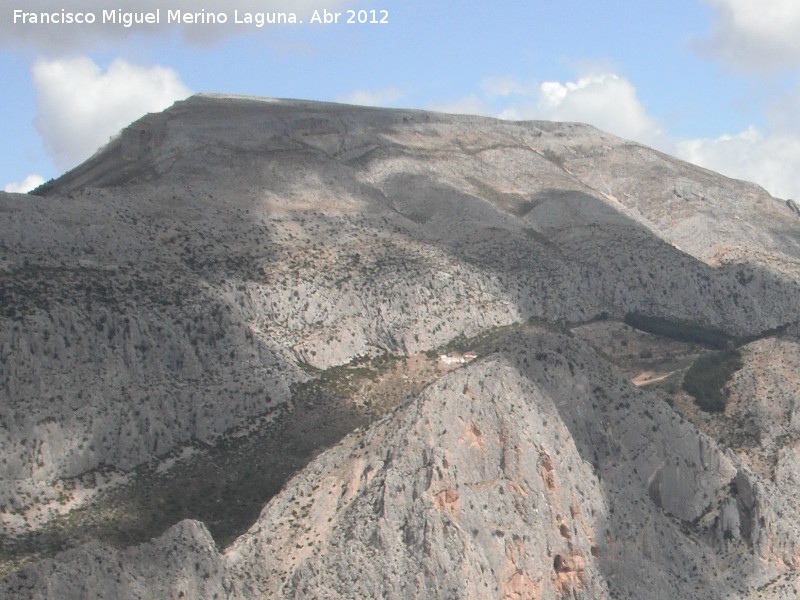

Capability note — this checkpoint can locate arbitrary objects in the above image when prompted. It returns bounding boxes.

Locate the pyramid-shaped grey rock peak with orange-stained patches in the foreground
[226,337,736,598]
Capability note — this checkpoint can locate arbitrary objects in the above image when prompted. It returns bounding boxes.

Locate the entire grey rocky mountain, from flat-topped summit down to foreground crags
[0,95,800,598]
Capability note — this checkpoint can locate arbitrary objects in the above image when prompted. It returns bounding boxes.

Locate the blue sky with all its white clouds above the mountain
[0,0,800,198]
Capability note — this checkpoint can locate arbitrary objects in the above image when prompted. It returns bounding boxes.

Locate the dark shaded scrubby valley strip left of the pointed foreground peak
[2,386,368,576]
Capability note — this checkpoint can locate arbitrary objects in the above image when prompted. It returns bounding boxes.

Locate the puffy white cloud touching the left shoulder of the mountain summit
[33,58,190,168]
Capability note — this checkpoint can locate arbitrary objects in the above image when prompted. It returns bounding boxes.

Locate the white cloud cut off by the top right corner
[699,0,800,71]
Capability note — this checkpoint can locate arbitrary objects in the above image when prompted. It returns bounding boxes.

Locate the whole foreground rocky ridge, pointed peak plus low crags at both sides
[6,334,800,598]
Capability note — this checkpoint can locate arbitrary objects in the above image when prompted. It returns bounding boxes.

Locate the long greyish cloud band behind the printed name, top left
[0,0,343,50]
